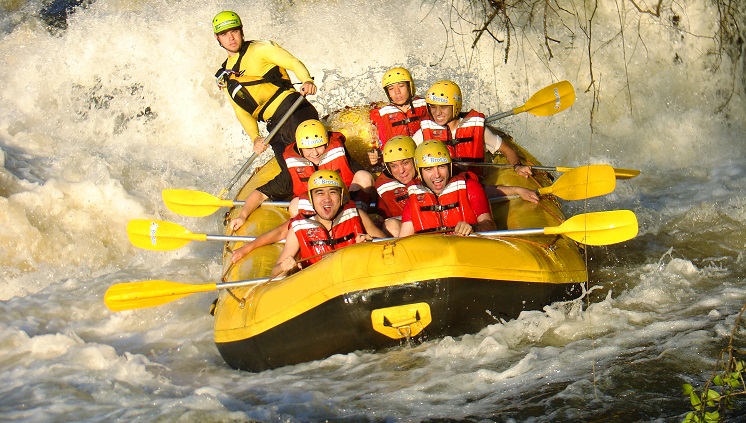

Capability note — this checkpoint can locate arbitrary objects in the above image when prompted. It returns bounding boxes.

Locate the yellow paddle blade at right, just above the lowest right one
[539,165,616,200]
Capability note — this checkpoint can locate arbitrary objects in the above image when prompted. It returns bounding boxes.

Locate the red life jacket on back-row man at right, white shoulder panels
[421,110,484,162]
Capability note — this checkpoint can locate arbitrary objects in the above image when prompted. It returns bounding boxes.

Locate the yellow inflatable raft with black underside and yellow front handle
[215,107,587,371]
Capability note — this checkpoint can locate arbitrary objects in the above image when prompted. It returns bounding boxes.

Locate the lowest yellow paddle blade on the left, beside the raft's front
[104,280,217,311]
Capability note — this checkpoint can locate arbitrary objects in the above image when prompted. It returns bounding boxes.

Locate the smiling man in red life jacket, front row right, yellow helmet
[399,140,497,237]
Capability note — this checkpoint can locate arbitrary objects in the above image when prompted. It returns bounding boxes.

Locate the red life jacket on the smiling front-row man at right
[407,173,477,232]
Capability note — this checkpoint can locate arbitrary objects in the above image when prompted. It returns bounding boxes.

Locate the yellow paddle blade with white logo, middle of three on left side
[127,219,207,251]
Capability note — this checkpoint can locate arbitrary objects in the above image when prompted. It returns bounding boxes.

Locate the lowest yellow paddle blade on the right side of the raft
[544,210,638,245]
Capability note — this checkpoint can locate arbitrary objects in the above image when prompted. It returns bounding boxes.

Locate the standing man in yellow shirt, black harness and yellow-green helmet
[212,11,319,172]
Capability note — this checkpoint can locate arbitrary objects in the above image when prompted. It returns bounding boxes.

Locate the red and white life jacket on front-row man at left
[290,201,365,265]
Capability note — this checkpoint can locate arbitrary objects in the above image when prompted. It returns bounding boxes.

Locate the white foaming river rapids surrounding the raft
[0,0,746,422]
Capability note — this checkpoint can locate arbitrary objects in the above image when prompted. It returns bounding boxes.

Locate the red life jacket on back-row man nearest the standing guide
[370,97,428,148]
